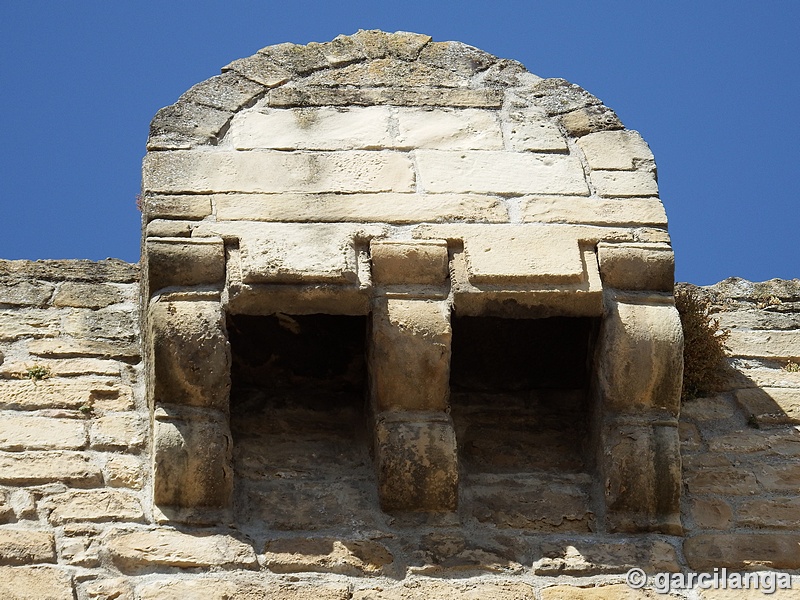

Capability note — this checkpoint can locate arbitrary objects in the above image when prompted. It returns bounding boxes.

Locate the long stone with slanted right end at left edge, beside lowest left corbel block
[0,451,103,487]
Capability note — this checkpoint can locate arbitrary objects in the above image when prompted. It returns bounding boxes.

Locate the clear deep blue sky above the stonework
[0,0,800,284]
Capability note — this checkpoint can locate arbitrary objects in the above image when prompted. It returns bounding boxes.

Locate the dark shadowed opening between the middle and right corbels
[450,317,599,531]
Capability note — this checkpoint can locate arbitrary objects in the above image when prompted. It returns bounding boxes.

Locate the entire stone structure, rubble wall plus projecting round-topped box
[0,31,800,600]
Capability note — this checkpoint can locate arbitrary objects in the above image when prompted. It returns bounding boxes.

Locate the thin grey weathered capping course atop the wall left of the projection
[0,258,139,283]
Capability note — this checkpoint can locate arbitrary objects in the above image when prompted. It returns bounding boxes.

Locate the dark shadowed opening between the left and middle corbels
[227,314,375,530]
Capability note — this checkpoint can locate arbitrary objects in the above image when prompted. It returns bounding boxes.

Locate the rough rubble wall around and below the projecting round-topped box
[0,261,800,600]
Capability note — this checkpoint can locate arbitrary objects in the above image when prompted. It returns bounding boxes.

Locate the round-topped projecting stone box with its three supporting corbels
[143,31,682,533]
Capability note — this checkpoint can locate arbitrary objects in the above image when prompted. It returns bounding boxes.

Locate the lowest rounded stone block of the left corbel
[152,409,233,508]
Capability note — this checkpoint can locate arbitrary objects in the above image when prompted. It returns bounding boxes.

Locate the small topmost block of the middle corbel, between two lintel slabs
[369,240,448,285]
